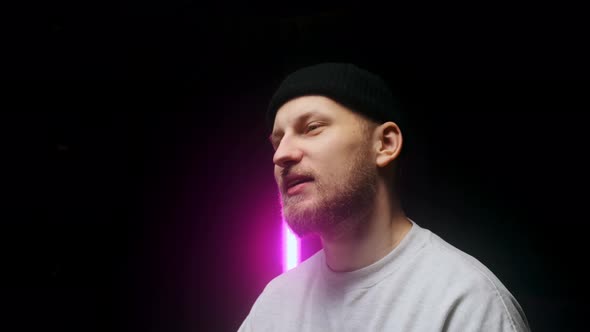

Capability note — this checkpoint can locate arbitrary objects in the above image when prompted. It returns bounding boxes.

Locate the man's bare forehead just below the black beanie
[273,96,355,131]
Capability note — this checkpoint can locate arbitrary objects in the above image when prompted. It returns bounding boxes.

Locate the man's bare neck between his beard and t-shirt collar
[320,184,412,272]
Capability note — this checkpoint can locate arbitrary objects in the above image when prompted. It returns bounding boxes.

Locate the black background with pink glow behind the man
[0,5,588,331]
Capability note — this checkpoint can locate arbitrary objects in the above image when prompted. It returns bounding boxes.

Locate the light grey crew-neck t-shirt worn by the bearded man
[239,221,530,332]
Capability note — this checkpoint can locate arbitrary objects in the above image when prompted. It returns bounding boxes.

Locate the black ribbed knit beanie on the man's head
[266,62,398,128]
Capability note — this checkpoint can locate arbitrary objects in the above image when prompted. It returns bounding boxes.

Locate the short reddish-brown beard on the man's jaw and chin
[281,147,377,237]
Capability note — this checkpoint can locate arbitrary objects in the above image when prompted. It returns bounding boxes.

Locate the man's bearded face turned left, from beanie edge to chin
[271,96,377,236]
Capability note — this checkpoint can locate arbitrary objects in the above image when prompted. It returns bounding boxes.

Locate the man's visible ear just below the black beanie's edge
[374,122,403,167]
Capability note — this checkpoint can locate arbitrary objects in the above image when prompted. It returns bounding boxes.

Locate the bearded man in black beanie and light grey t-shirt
[240,63,530,332]
